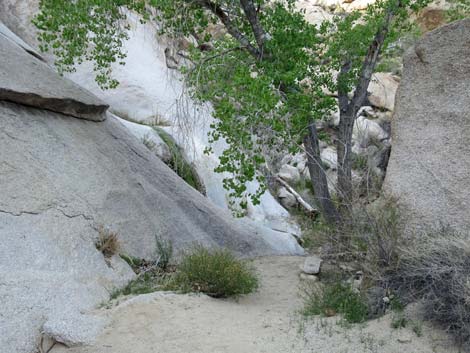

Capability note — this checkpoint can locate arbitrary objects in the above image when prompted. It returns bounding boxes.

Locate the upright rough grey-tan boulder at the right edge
[385,19,470,232]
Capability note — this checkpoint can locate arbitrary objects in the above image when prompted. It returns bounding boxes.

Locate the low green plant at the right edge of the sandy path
[303,282,367,323]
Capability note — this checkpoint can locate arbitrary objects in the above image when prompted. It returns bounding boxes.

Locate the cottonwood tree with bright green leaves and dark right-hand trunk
[35,0,427,224]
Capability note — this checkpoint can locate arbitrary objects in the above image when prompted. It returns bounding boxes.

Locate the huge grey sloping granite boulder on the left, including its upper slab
[0,34,302,353]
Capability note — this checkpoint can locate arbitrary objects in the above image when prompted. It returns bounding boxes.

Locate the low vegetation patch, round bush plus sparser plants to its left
[111,245,258,299]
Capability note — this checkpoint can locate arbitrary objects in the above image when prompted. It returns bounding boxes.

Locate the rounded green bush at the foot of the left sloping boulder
[174,246,258,298]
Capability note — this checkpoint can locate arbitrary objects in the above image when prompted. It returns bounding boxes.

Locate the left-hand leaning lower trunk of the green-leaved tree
[304,123,340,224]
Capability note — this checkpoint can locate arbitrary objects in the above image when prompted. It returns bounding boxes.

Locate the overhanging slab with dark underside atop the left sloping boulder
[0,26,108,121]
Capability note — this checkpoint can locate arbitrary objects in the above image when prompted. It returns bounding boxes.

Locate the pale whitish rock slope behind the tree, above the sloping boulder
[0,0,300,235]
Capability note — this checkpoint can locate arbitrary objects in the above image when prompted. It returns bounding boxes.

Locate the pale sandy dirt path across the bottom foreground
[52,257,458,353]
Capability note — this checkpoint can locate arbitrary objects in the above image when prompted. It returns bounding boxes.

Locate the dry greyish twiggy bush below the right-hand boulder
[383,228,470,349]
